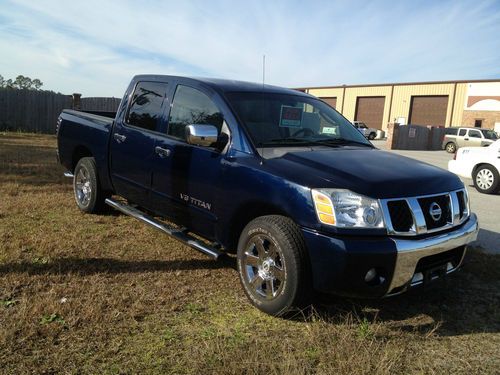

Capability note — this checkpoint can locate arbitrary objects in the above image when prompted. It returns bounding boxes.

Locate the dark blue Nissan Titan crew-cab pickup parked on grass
[57,75,478,315]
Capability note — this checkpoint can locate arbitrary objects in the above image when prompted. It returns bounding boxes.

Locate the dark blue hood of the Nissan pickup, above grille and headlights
[267,147,463,198]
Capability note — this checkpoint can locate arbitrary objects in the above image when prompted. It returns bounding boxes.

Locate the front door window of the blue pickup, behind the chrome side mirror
[167,85,223,140]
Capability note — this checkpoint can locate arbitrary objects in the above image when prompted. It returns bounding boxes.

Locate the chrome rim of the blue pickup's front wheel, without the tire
[242,234,286,300]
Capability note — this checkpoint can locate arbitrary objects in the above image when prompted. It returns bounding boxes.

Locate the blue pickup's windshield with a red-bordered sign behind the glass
[227,92,372,147]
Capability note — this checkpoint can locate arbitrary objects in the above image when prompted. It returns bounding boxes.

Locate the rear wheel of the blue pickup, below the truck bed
[73,157,108,214]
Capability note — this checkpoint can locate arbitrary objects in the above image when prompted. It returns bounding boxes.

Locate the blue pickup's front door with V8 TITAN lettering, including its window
[151,85,224,238]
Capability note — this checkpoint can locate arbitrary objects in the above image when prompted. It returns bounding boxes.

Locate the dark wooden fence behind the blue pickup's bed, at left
[0,89,120,134]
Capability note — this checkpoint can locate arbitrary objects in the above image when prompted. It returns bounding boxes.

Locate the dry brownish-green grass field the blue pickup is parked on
[0,133,500,374]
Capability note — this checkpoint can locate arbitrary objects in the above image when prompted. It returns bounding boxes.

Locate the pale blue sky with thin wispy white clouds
[0,0,500,97]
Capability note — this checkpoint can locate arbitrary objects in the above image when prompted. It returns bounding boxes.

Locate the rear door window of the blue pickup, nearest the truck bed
[126,82,167,130]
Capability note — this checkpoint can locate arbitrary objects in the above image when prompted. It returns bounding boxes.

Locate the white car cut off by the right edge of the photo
[448,139,500,194]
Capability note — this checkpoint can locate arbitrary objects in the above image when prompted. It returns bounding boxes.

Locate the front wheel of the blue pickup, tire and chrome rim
[237,215,312,316]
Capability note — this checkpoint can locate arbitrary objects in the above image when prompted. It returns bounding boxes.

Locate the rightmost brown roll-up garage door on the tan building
[409,95,448,126]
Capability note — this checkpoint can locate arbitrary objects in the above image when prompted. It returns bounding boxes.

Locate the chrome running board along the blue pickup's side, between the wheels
[105,198,224,260]
